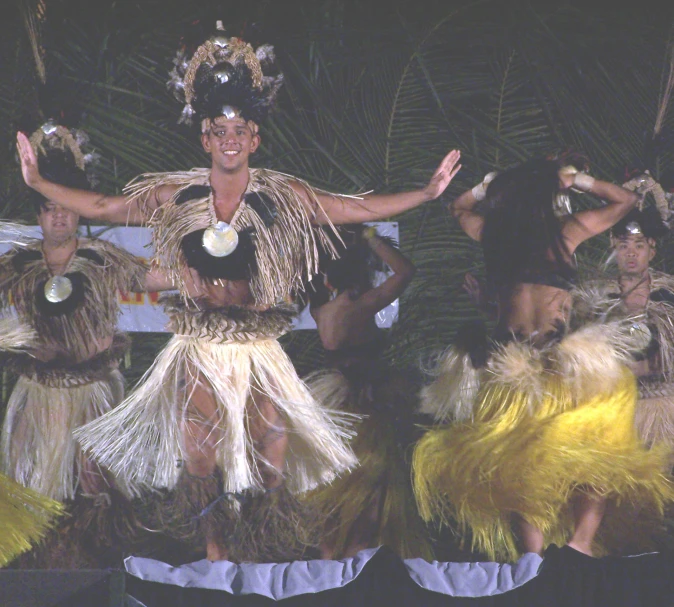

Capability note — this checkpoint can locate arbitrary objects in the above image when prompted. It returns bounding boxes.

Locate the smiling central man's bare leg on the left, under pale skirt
[181,370,228,561]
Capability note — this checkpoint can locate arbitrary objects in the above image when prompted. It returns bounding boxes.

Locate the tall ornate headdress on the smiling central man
[167,21,283,132]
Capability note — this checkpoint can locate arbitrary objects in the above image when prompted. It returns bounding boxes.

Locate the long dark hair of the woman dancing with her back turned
[482,160,573,288]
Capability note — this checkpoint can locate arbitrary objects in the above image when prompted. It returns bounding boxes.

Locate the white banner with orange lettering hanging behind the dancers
[0,222,398,332]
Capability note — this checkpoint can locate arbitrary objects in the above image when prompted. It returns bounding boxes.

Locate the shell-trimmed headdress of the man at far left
[30,120,98,189]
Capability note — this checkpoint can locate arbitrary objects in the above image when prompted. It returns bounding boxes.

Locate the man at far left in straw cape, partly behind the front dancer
[0,122,171,567]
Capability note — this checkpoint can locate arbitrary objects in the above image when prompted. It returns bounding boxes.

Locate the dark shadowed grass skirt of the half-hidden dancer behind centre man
[307,369,433,560]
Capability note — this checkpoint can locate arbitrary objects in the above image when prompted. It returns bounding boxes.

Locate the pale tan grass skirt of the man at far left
[1,369,124,501]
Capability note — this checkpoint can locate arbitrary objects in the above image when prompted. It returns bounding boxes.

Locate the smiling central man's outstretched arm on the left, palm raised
[16,132,170,225]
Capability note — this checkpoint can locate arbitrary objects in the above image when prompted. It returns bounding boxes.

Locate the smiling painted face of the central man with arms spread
[201,117,260,172]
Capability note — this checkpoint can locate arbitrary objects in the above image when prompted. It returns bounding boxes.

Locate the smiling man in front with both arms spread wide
[18,31,459,560]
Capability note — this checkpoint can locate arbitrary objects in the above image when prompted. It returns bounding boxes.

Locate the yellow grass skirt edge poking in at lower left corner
[0,474,63,567]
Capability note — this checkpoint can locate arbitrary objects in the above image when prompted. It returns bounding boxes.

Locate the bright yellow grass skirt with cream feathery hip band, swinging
[413,323,674,560]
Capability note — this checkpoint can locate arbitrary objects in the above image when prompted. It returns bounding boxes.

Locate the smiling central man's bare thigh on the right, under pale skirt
[248,391,288,489]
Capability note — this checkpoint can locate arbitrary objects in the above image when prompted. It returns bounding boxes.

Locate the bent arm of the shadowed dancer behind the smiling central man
[357,228,416,315]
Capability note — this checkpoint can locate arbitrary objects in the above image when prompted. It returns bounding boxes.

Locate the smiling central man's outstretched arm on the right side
[296,150,461,224]
